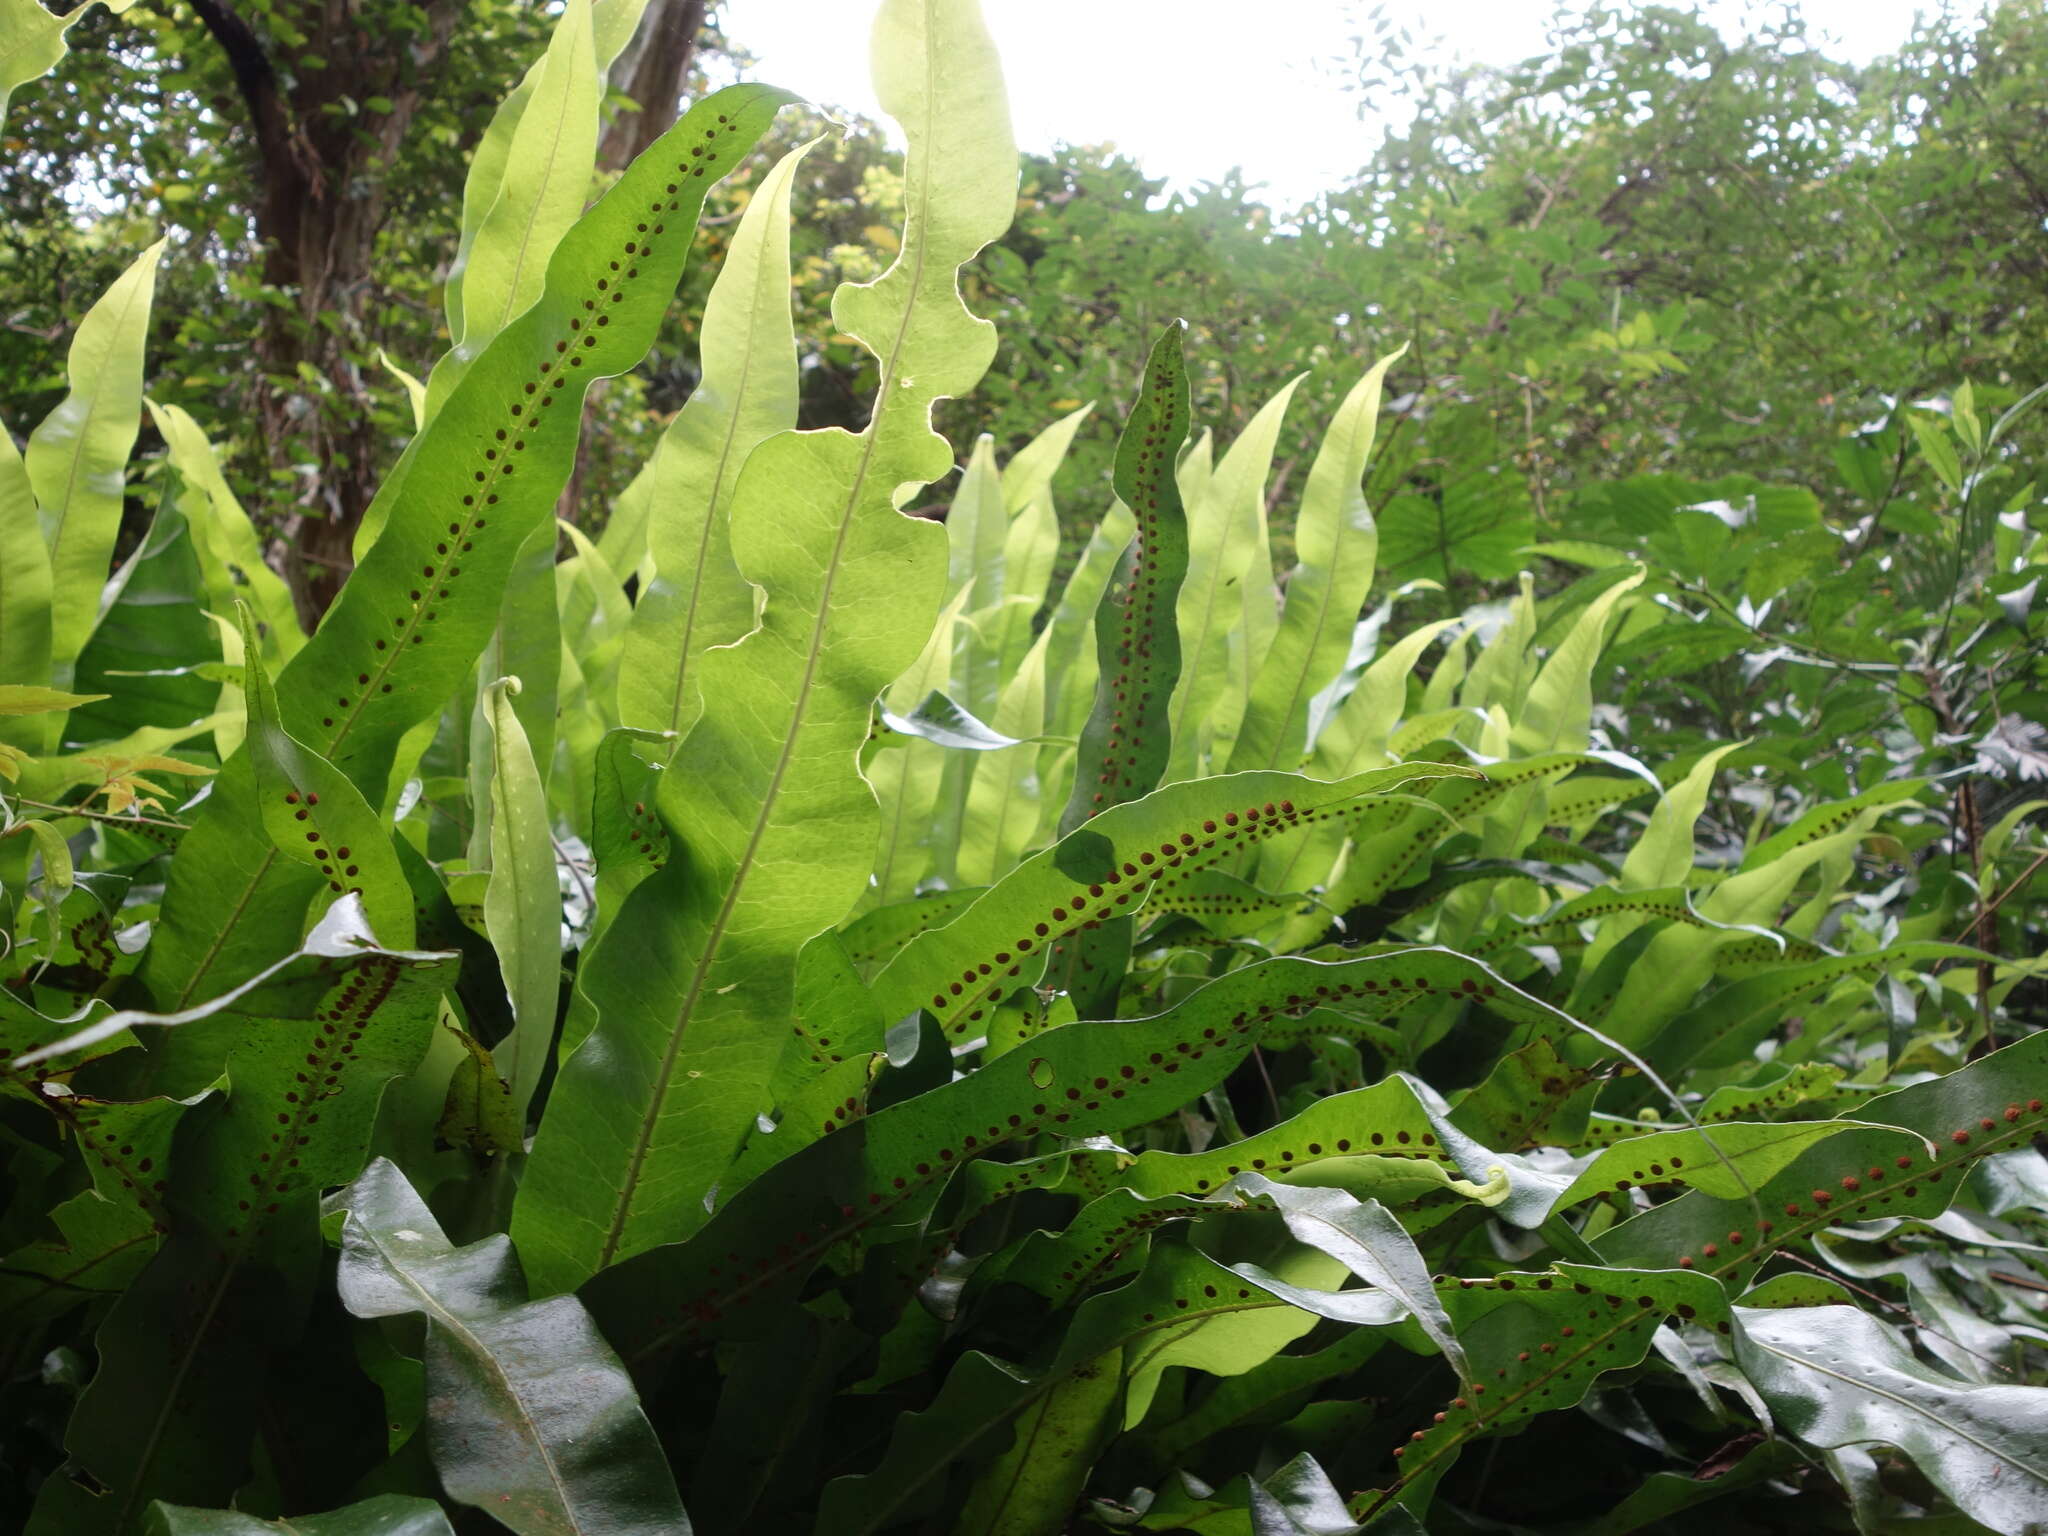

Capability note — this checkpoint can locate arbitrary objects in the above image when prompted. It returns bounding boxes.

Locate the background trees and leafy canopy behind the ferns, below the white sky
[16,0,2048,593]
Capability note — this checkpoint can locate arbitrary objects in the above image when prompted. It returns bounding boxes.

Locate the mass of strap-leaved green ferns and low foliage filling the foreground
[0,0,2048,1536]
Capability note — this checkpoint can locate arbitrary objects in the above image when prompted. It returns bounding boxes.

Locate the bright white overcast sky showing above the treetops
[721,0,1927,207]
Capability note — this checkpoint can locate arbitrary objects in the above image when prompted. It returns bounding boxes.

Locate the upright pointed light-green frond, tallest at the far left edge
[25,240,164,686]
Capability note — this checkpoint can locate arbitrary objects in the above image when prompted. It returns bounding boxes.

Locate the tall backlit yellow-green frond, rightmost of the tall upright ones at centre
[1231,346,1407,770]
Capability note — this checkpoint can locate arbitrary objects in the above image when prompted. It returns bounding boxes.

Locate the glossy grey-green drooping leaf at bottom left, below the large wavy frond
[336,1159,688,1536]
